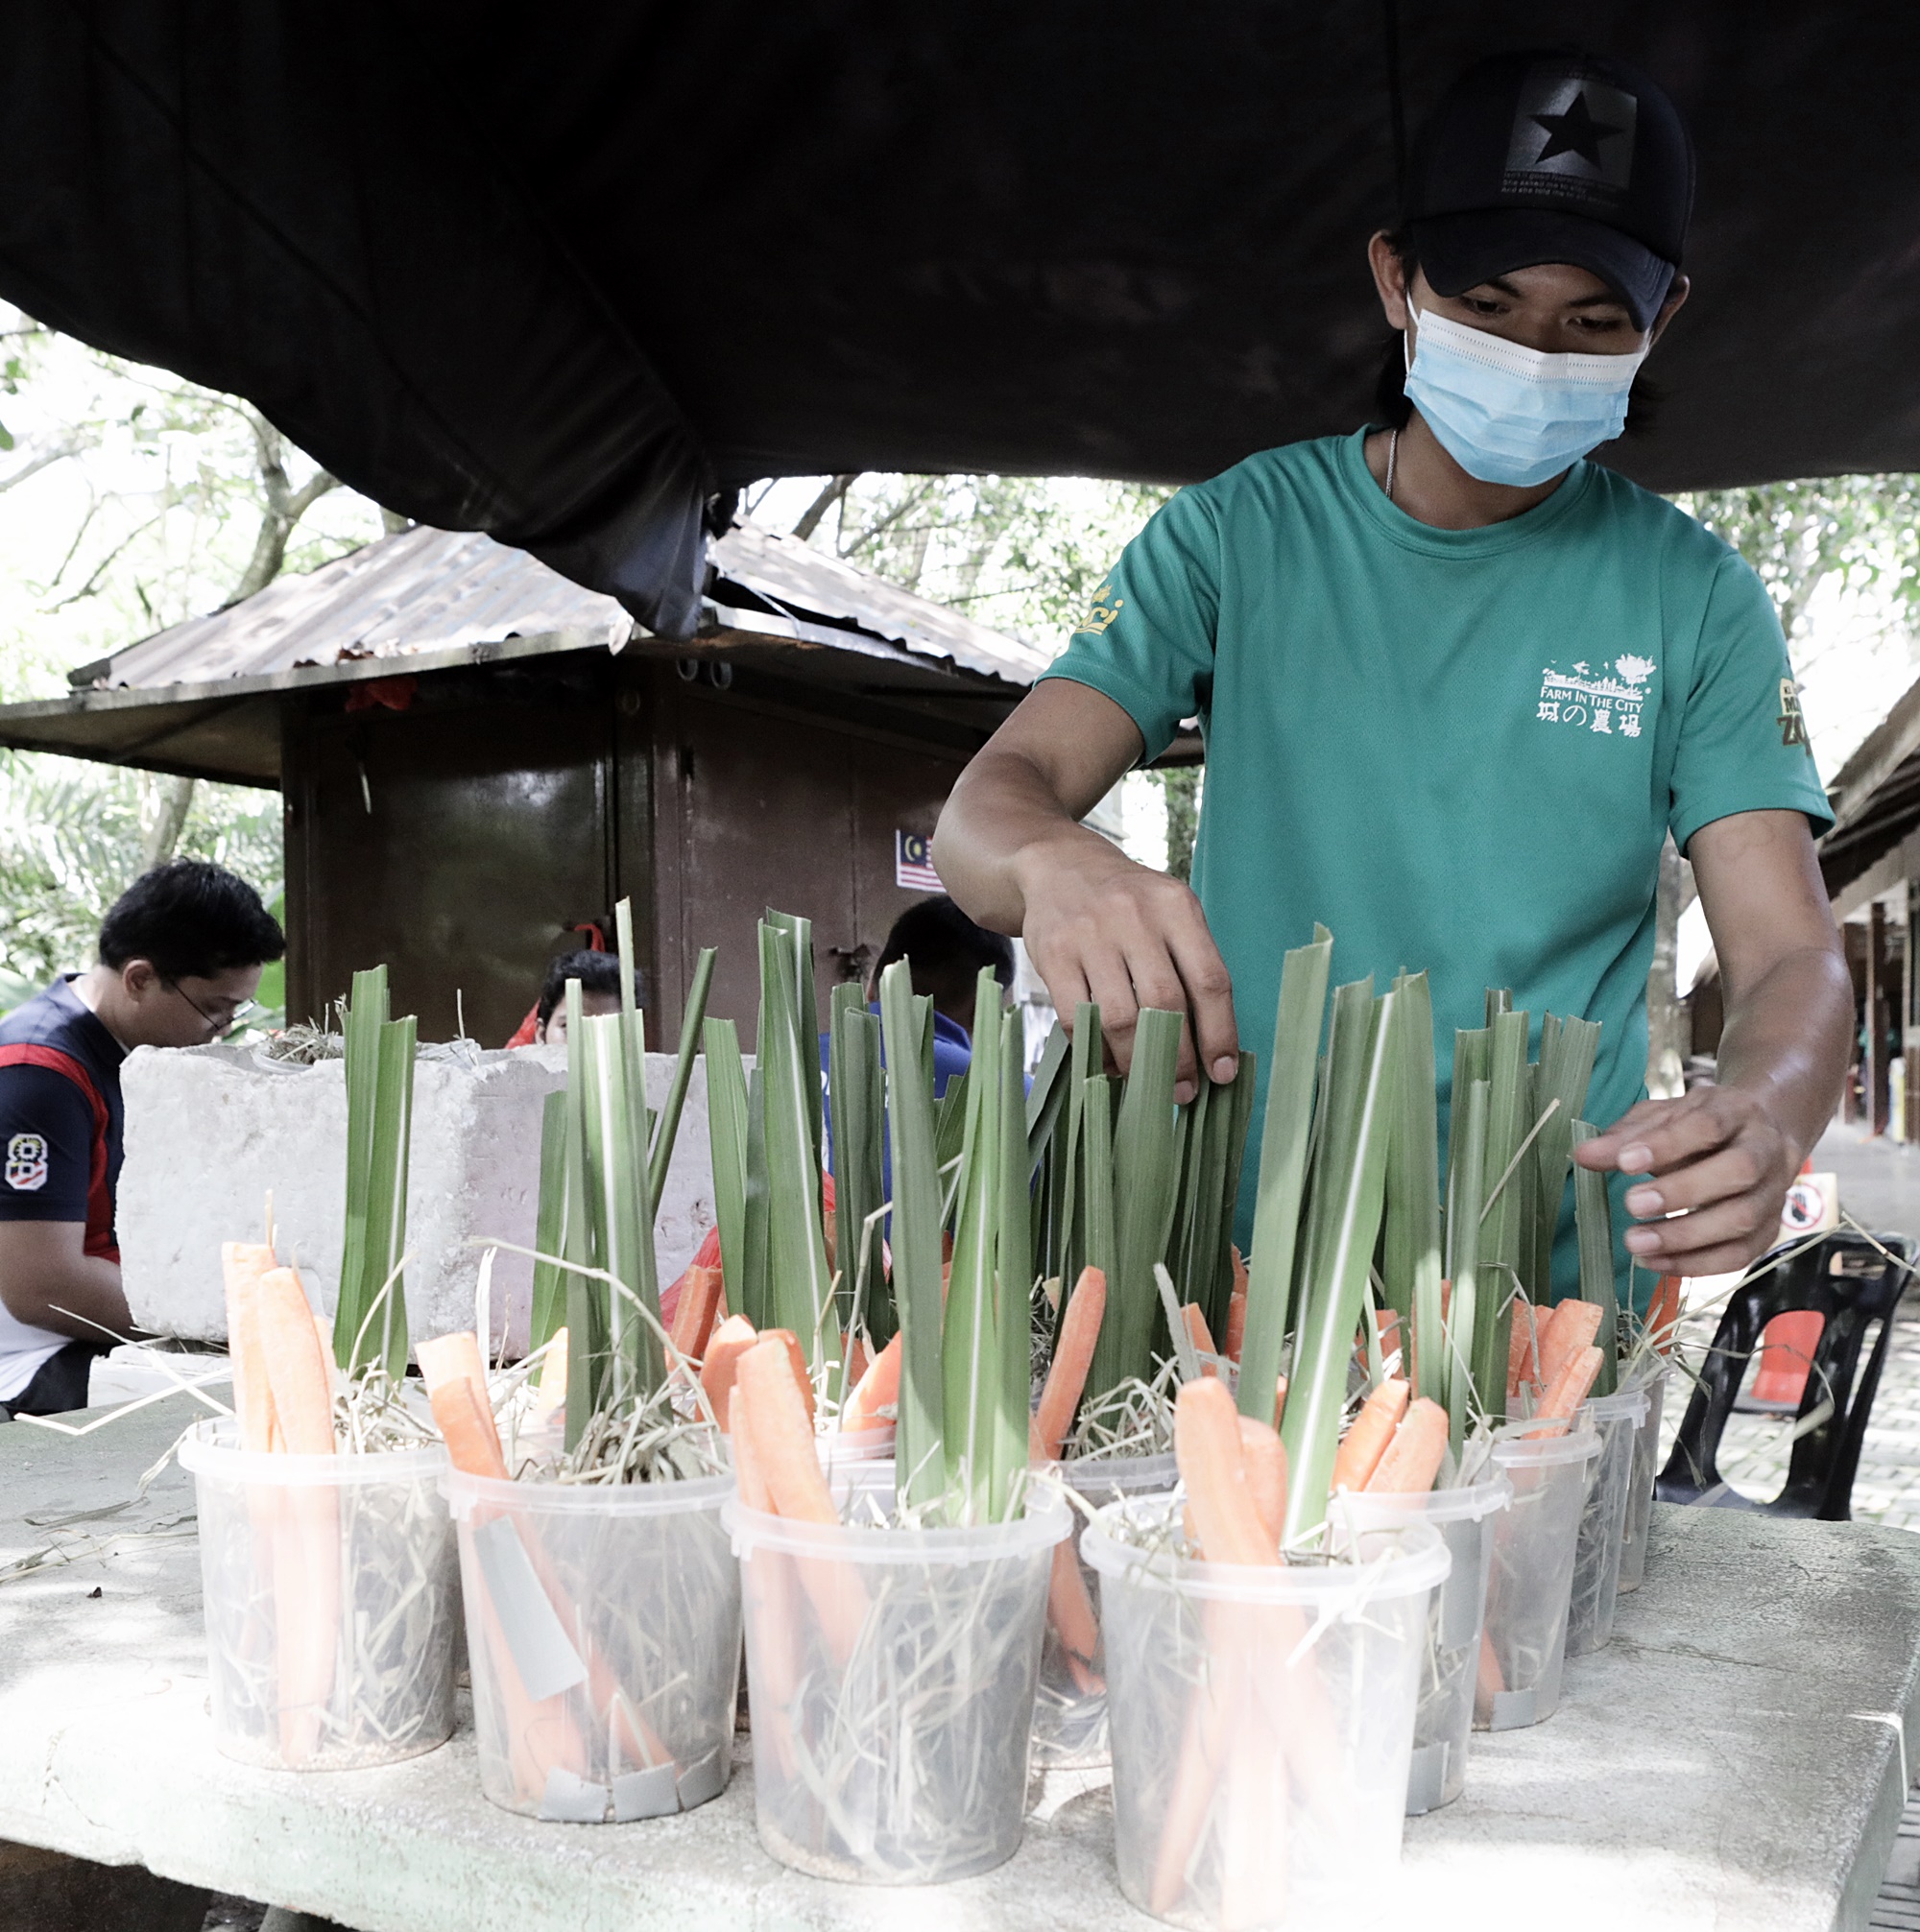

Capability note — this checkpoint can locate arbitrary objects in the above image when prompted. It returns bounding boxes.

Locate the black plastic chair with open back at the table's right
[1653,1232,1920,1522]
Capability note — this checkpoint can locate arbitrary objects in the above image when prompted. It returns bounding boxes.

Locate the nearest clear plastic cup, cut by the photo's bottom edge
[1082,1495,1449,1932]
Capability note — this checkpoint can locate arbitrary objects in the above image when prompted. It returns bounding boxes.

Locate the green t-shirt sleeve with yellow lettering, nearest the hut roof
[1045,489,1221,759]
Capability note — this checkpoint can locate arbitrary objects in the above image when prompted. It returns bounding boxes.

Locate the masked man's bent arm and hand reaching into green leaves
[933,679,1240,1101]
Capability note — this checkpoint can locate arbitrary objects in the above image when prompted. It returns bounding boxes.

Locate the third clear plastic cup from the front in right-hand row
[1474,1422,1599,1731]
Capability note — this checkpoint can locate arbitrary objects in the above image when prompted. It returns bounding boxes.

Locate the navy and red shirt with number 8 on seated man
[0,978,128,1261]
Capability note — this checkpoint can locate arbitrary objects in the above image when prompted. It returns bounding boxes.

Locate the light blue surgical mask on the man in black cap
[1406,311,1645,489]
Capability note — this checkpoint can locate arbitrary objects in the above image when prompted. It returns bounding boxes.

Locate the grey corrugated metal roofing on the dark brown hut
[75,524,1047,690]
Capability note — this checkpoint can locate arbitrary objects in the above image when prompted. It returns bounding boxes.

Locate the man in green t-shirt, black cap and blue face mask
[935,52,1853,1287]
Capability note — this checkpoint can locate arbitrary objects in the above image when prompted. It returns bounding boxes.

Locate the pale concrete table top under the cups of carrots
[0,1400,1920,1932]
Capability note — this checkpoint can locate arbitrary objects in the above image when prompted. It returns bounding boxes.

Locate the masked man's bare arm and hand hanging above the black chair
[1574,811,1853,1276]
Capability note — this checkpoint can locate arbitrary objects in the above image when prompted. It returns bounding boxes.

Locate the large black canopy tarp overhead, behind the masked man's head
[0,0,1920,632]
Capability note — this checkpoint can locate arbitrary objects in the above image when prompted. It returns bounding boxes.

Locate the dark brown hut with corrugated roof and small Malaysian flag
[0,524,1047,1045]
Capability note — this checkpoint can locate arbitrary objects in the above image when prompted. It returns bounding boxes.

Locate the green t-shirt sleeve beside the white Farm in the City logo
[1668,557,1833,852]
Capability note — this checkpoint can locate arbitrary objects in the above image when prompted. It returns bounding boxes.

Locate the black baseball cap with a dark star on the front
[1404,48,1694,328]
